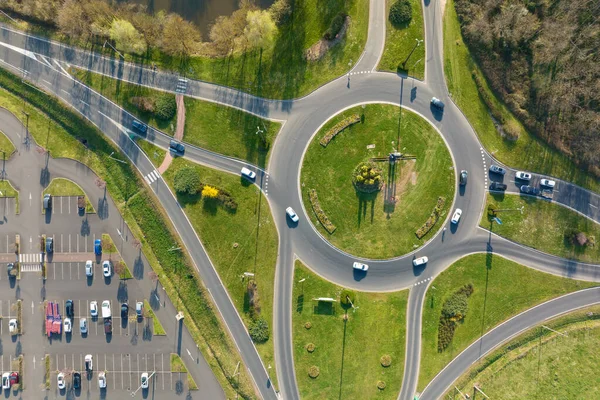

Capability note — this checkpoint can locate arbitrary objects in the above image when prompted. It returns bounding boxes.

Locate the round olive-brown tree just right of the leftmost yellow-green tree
[161,14,202,58]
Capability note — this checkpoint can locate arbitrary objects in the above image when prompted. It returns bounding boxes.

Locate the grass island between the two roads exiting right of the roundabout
[479,194,600,263]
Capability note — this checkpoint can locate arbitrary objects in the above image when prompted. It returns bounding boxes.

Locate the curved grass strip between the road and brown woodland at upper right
[444,0,600,193]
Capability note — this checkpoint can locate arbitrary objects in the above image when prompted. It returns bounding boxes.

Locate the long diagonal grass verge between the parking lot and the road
[0,65,255,399]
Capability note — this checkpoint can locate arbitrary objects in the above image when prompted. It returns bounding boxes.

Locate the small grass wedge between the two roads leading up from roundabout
[377,0,425,79]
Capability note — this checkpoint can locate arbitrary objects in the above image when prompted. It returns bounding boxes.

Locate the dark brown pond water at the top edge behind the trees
[120,0,274,36]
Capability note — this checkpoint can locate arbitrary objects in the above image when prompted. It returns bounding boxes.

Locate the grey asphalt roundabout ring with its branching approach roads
[0,0,600,399]
